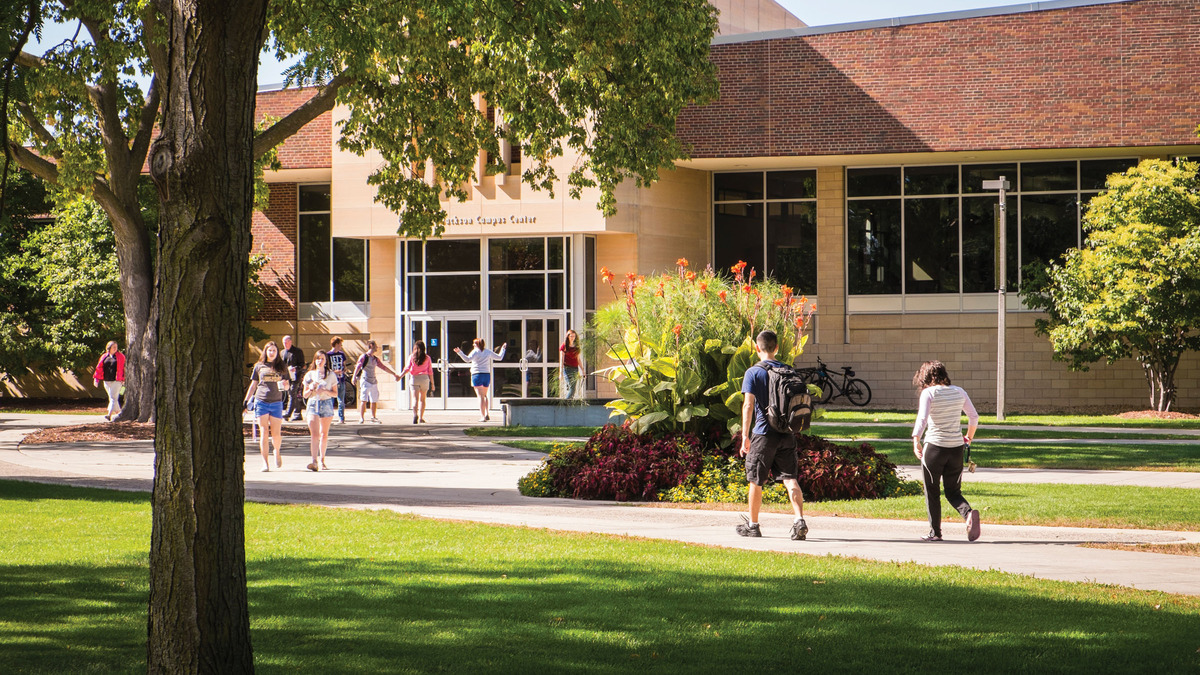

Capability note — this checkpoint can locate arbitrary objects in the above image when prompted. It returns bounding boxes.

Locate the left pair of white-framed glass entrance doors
[410,316,479,410]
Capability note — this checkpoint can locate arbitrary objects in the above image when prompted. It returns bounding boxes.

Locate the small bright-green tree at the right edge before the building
[1021,160,1200,411]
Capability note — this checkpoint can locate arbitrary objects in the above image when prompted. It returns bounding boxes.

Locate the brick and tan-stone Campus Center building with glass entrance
[254,0,1200,410]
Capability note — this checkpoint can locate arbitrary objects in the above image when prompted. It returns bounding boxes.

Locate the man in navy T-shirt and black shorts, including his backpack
[736,330,811,540]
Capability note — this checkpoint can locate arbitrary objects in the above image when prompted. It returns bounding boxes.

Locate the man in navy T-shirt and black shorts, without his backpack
[734,330,809,542]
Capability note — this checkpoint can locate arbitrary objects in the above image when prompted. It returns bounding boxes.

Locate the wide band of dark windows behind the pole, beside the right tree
[846,159,1136,295]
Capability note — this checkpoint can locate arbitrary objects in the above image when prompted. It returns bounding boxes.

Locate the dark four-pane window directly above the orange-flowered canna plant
[713,171,817,295]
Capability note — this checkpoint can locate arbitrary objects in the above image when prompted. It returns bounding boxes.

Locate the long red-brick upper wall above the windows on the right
[678,0,1200,157]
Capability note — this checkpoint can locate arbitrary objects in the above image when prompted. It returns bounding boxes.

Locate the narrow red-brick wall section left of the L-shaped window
[250,183,299,322]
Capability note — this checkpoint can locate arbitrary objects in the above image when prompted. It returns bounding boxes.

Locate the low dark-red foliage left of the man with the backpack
[517,425,703,501]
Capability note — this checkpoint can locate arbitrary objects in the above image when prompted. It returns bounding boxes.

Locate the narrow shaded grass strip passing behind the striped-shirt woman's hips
[870,441,1200,471]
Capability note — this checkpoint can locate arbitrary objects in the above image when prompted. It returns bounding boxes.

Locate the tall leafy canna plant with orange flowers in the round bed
[590,258,816,444]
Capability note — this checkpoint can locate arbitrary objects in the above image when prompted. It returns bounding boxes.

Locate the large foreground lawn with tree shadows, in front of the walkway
[0,482,1200,674]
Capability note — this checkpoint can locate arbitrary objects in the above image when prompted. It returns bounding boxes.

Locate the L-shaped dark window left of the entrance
[298,185,370,303]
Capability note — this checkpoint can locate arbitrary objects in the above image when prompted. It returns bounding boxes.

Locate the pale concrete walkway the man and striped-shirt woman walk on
[0,412,1200,595]
